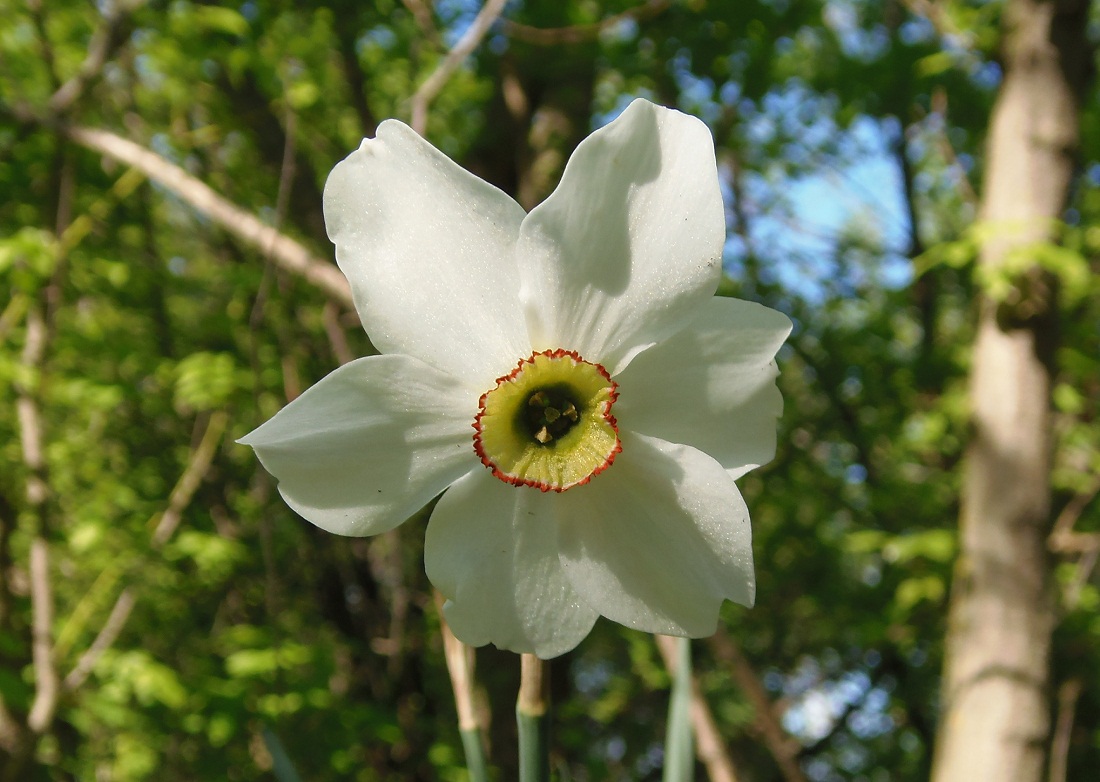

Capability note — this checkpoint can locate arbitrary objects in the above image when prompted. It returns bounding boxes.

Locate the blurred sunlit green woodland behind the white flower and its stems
[0,0,1100,782]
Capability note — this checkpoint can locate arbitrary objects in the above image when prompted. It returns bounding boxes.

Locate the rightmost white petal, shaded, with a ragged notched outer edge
[615,298,791,477]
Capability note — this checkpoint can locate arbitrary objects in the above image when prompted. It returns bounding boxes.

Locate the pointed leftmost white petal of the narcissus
[240,355,481,536]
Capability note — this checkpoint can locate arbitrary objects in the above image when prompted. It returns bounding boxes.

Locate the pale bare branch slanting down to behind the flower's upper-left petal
[62,128,354,307]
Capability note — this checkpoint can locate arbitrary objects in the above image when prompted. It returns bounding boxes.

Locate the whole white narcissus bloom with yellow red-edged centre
[242,100,791,658]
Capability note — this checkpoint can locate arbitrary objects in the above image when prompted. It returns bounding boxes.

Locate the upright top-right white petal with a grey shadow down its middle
[518,100,725,374]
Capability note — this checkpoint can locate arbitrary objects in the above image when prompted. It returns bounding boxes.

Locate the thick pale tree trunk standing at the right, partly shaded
[933,0,1089,782]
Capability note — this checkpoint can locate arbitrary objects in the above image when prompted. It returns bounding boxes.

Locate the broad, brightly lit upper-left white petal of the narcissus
[325,120,530,390]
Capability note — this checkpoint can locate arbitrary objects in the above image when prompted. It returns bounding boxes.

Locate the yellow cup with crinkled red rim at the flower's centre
[473,348,623,492]
